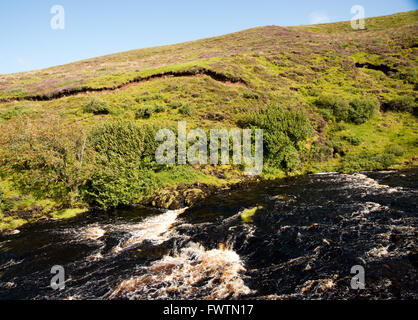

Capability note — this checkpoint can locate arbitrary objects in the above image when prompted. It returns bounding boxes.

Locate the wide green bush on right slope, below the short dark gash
[315,95,378,124]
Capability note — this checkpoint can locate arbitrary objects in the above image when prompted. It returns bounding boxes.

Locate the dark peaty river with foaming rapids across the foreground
[0,170,418,299]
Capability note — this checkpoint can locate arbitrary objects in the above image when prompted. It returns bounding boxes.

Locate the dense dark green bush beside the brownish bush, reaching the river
[83,120,157,209]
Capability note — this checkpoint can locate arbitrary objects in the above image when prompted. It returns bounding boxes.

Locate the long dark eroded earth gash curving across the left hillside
[0,68,247,102]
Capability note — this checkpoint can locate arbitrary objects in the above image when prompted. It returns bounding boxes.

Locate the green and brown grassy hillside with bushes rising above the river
[0,11,418,227]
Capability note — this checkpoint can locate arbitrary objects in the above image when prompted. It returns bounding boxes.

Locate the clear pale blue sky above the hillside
[0,0,418,74]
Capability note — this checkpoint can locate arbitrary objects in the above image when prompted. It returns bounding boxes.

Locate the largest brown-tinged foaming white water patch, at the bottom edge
[110,243,251,299]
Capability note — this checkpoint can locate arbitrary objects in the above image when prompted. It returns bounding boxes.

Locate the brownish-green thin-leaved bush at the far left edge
[0,115,94,205]
